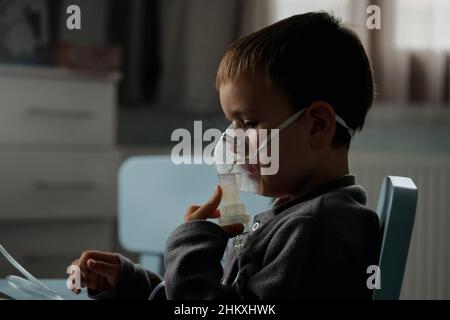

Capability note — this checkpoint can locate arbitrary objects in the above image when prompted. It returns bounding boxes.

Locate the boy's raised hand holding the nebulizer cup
[184,186,244,238]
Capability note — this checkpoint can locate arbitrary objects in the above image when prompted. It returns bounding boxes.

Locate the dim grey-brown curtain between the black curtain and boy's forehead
[159,0,242,112]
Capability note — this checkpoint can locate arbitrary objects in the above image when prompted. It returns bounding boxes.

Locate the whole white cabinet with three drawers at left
[0,65,120,277]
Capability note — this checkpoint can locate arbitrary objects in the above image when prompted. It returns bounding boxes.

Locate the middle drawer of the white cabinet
[0,149,119,219]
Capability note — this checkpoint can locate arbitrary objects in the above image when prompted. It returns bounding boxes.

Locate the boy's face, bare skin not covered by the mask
[220,71,325,197]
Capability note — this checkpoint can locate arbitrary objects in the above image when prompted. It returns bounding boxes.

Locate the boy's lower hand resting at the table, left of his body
[67,251,120,294]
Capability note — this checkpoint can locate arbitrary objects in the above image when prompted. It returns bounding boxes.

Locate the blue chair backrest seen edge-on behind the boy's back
[373,176,418,300]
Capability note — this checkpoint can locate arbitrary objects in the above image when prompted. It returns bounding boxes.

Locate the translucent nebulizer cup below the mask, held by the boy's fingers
[219,173,250,252]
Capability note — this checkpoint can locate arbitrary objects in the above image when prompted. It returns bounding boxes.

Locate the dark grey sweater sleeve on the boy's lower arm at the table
[88,254,162,300]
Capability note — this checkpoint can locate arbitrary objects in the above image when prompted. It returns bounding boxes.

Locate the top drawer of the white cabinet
[0,76,116,145]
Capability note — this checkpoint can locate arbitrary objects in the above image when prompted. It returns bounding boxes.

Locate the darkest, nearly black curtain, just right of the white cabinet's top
[107,0,161,106]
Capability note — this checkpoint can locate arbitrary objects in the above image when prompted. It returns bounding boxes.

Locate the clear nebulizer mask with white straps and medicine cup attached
[214,109,353,251]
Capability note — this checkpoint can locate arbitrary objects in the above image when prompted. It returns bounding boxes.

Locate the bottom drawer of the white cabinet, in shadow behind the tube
[0,221,115,278]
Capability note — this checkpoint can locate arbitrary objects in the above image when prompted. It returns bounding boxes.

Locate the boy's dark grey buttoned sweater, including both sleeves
[90,175,381,299]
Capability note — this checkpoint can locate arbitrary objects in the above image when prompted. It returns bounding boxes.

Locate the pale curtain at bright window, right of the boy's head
[369,0,450,105]
